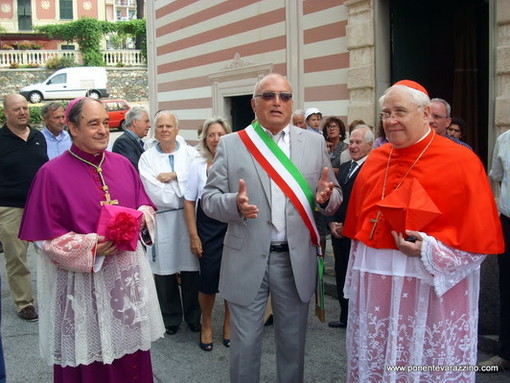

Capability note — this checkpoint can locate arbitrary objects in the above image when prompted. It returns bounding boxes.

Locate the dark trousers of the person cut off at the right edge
[498,218,510,360]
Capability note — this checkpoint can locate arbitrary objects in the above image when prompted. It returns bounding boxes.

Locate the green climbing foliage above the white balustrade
[35,17,147,66]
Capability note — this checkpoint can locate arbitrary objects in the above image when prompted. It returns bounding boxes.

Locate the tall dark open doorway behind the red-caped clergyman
[389,0,489,164]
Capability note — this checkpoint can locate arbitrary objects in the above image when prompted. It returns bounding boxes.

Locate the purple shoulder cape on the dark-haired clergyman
[20,145,155,241]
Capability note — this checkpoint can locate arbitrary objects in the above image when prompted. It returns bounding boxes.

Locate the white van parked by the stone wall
[19,67,109,104]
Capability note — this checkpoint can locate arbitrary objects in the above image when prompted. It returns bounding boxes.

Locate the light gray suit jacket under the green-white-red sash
[202,126,342,305]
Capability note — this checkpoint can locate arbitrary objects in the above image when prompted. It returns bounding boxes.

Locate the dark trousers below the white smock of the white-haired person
[154,271,200,328]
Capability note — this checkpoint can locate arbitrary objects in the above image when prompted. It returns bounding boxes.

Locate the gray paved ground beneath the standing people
[0,246,510,383]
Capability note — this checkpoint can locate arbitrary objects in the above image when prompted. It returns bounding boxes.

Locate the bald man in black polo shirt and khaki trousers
[0,94,48,321]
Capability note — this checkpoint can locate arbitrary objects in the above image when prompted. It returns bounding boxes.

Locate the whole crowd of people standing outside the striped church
[0,73,510,383]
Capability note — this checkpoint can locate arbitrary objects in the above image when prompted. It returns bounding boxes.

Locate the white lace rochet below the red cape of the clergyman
[344,233,485,383]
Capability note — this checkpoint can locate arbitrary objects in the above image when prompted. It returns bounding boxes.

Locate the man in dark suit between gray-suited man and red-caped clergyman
[328,125,374,328]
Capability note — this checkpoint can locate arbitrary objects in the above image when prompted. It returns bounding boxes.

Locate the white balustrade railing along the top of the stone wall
[0,49,147,68]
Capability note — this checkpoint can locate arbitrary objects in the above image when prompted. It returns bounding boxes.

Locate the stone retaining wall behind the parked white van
[0,68,149,102]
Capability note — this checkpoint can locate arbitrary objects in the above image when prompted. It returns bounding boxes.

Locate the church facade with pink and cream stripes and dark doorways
[146,0,510,168]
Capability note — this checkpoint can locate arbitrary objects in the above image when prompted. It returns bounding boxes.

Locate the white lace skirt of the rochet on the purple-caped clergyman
[37,243,165,367]
